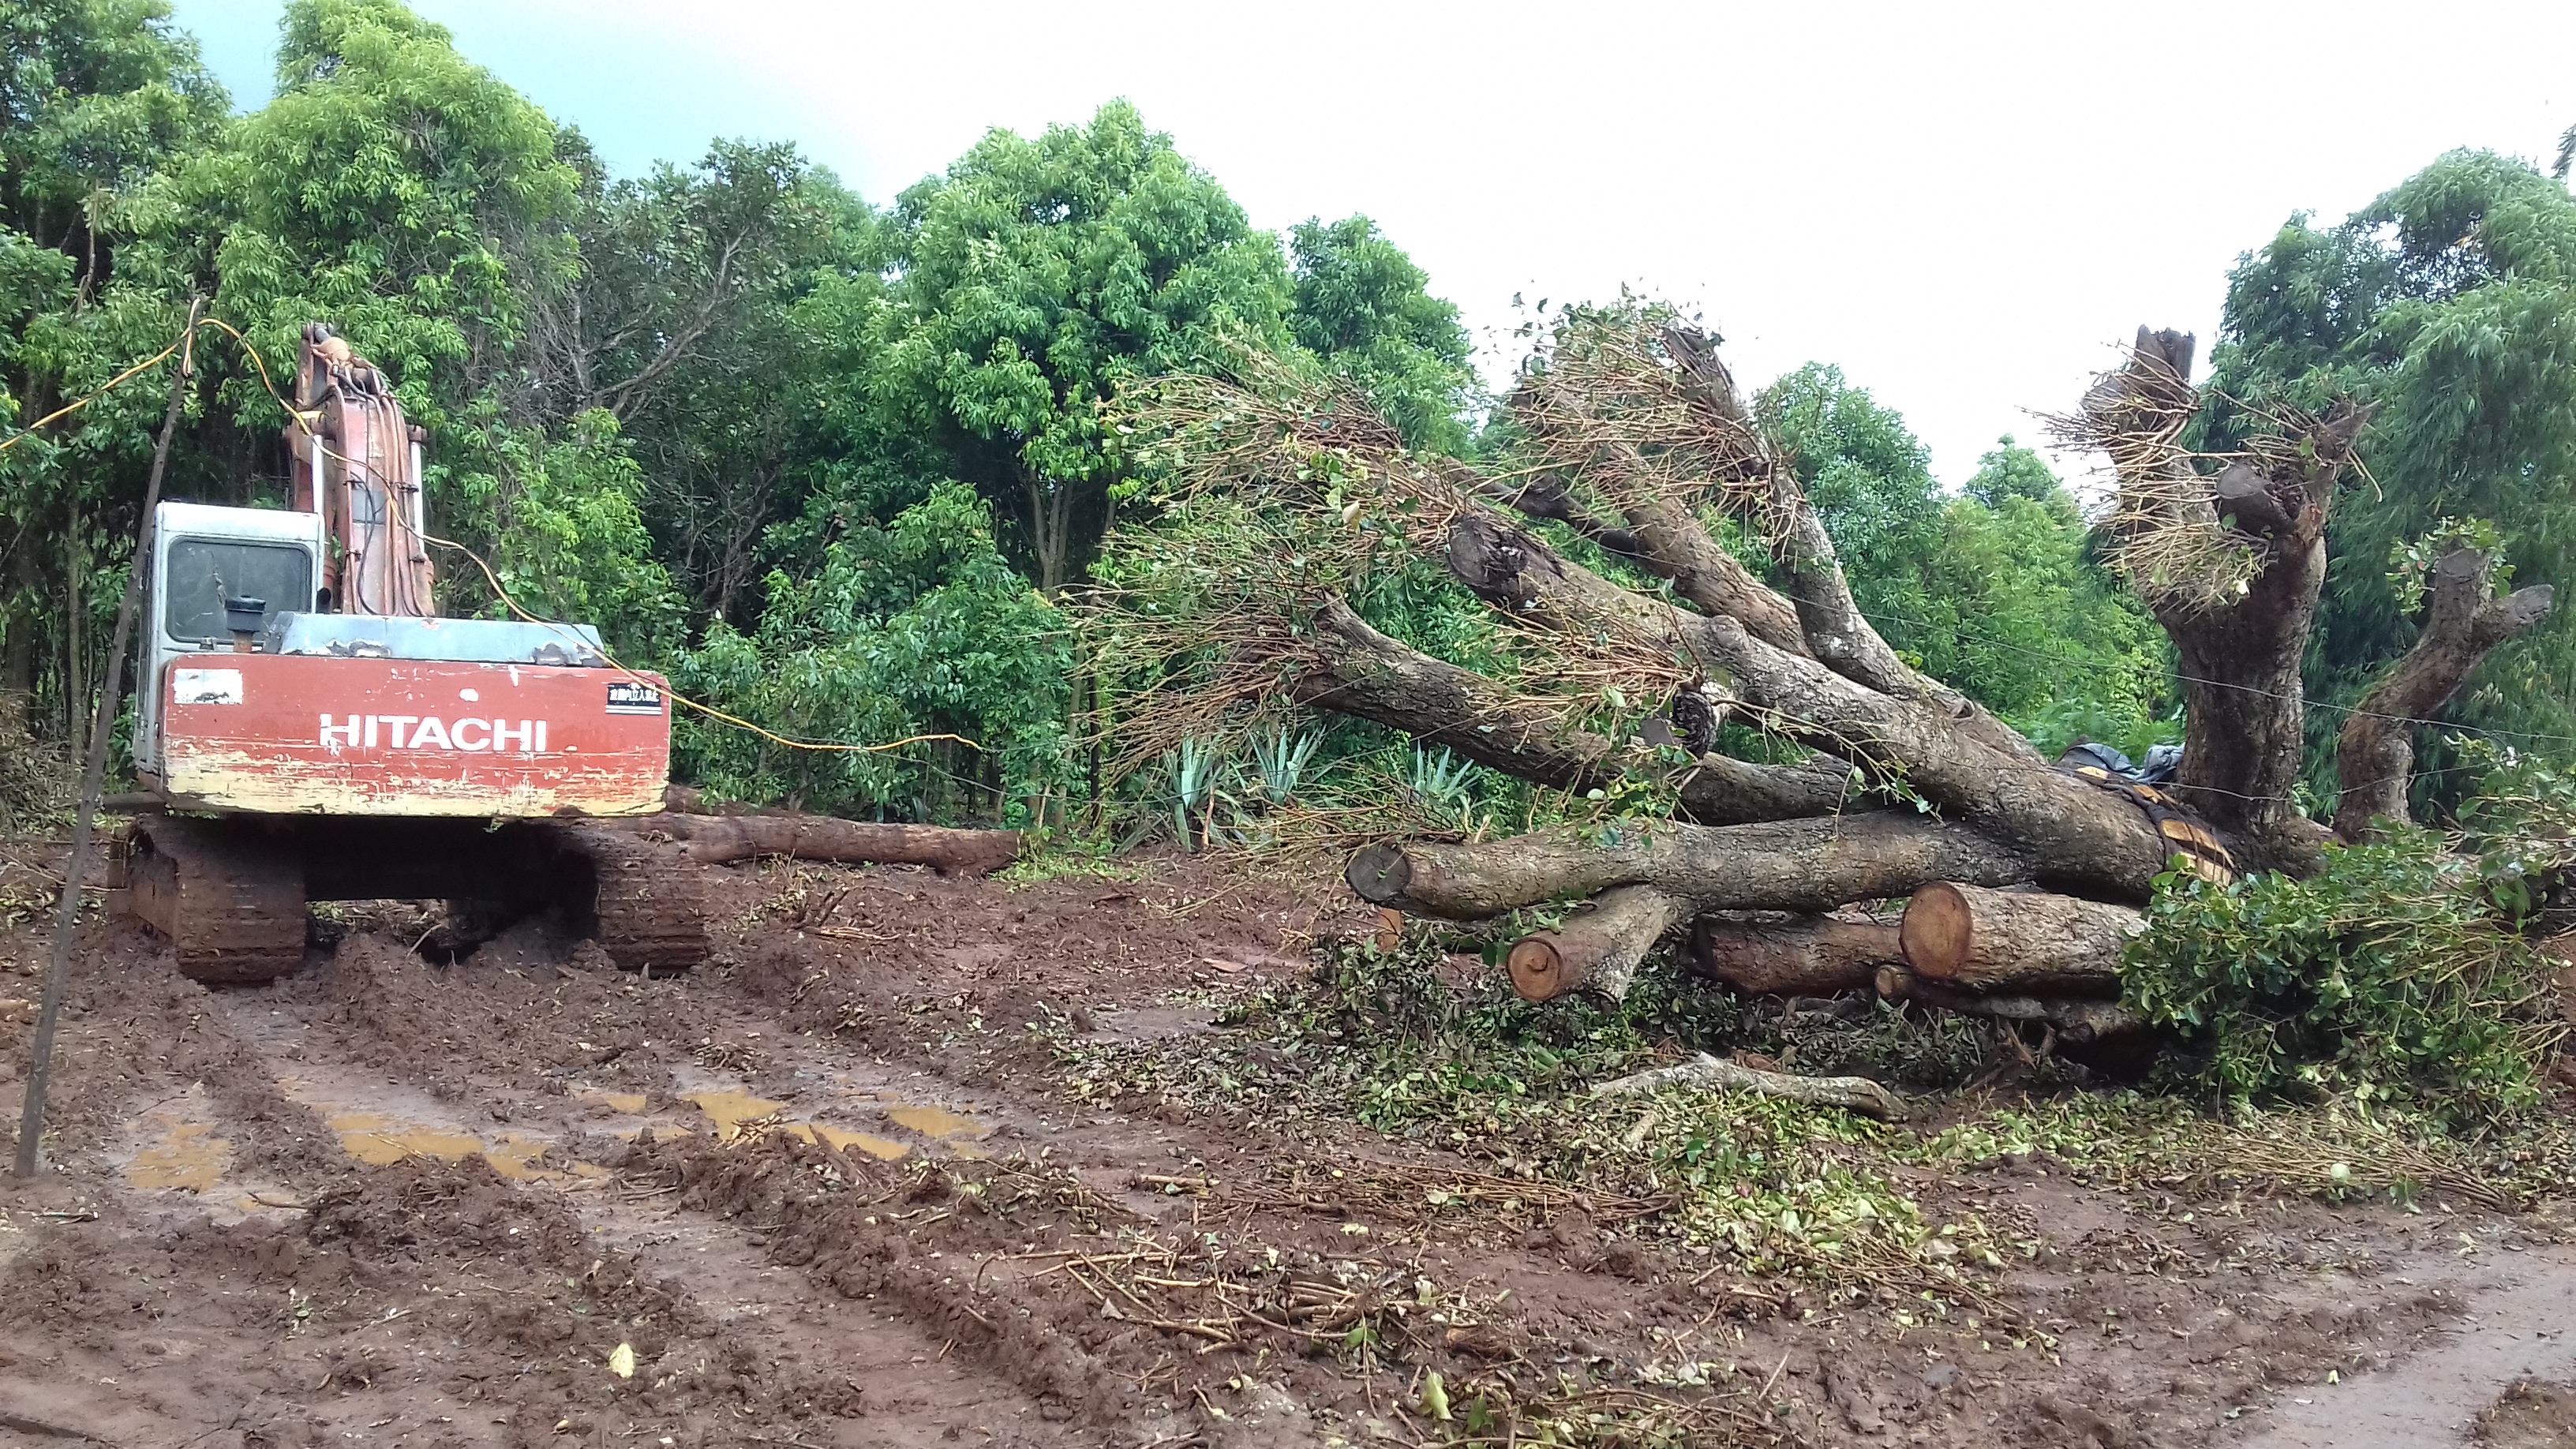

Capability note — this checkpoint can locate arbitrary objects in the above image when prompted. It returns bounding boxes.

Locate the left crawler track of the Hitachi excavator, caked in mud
[121,814,304,983]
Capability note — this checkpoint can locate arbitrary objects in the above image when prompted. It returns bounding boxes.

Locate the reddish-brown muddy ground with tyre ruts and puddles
[0,846,2576,1449]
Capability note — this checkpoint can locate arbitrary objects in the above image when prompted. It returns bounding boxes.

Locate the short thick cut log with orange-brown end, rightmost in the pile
[1901,882,2144,995]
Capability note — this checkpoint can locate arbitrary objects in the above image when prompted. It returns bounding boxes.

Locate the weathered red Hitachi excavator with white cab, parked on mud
[110,322,706,983]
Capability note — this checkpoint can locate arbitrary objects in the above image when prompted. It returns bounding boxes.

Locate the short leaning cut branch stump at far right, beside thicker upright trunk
[2334,549,2553,841]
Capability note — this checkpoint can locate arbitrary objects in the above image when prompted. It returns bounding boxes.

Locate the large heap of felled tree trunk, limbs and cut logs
[1082,307,2550,1042]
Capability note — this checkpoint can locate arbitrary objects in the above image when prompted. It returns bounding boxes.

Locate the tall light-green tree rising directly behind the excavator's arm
[157,0,579,572]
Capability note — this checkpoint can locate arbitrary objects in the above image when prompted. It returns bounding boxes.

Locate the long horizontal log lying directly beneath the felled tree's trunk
[1342,812,2030,920]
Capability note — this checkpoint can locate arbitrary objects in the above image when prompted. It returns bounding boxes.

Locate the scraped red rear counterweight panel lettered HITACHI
[159,655,670,818]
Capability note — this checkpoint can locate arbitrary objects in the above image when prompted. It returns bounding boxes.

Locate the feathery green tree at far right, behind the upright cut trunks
[2205,152,2576,784]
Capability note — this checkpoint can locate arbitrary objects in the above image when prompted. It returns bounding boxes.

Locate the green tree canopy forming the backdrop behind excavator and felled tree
[0,0,2576,841]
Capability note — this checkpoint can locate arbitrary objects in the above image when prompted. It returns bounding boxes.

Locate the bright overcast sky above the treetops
[178,0,2576,485]
